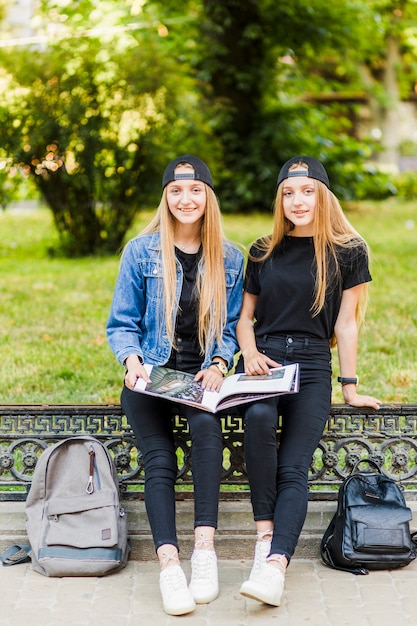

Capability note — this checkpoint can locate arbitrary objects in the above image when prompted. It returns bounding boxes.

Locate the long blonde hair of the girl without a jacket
[251,162,370,338]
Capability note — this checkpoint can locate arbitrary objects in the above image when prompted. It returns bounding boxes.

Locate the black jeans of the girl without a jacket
[238,336,331,560]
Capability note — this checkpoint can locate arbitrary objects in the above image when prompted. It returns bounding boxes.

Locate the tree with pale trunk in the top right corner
[270,0,417,169]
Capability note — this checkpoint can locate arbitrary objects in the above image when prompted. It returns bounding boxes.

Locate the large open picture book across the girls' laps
[134,363,299,413]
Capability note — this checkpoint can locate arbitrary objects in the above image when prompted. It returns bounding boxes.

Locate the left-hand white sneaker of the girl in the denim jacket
[159,565,195,615]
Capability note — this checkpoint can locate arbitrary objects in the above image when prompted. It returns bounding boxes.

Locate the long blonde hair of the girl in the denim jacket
[142,176,227,354]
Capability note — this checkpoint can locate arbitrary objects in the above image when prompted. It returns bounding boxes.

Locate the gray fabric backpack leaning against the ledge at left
[3,436,129,576]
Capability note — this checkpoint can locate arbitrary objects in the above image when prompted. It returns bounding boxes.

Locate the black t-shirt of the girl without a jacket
[245,236,372,340]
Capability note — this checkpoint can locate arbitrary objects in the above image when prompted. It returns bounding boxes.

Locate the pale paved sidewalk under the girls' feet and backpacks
[0,559,417,626]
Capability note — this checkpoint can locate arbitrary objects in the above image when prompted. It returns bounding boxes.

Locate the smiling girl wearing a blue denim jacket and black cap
[107,155,243,615]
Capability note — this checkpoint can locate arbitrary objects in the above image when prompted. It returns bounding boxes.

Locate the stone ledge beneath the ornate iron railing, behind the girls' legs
[0,500,417,561]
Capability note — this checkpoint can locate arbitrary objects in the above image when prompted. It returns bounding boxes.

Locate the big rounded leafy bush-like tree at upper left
[0,0,206,255]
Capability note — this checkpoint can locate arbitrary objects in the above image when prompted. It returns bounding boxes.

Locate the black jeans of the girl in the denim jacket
[121,342,223,550]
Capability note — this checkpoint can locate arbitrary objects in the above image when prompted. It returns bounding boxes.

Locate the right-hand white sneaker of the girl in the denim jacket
[190,550,219,604]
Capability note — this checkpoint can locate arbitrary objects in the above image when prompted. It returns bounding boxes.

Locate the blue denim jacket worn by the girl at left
[107,233,243,369]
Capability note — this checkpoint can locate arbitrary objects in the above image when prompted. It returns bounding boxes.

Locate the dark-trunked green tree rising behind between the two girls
[193,0,382,210]
